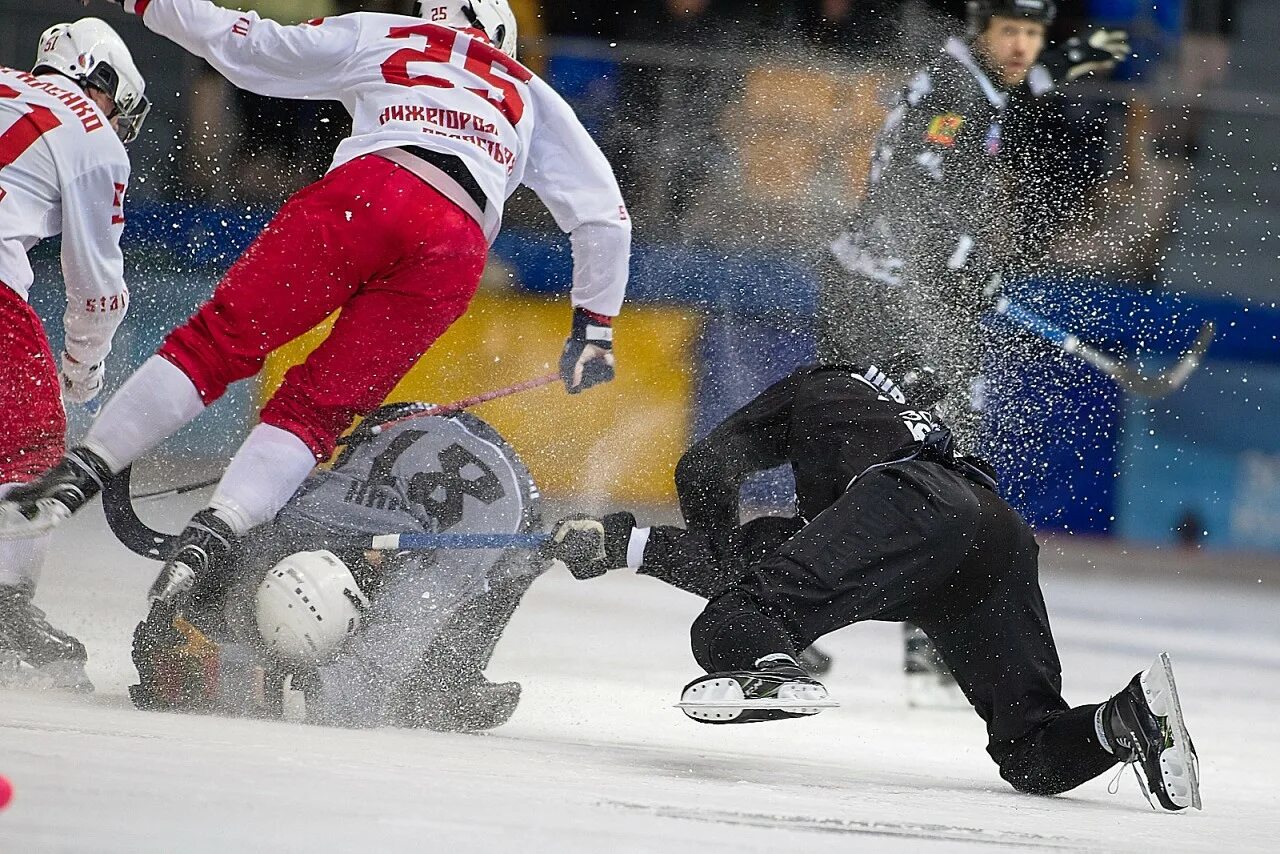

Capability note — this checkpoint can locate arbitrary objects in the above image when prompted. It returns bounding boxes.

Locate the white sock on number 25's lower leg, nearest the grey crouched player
[209,424,316,535]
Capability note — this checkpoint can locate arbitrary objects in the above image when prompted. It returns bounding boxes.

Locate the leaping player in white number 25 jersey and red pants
[0,0,631,632]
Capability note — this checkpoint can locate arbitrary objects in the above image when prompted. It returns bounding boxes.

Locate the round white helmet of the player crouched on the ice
[255,551,369,666]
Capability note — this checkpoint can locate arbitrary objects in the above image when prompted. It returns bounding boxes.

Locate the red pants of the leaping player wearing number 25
[160,155,488,460]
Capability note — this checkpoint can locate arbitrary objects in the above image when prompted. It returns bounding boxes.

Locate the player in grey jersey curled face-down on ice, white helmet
[131,407,541,730]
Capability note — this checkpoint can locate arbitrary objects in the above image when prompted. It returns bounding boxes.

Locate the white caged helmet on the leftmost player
[32,18,151,142]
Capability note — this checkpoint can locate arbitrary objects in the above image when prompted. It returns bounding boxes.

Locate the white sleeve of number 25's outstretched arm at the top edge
[124,0,360,99]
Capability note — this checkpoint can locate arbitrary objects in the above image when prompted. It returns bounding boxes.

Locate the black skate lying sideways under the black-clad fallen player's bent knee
[676,654,840,723]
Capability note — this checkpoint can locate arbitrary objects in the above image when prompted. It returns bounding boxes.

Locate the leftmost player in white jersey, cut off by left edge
[0,18,148,689]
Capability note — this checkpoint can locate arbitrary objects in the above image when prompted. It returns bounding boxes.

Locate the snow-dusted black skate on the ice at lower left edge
[0,584,93,691]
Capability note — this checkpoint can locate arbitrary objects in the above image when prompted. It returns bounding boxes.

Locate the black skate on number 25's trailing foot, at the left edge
[0,448,111,539]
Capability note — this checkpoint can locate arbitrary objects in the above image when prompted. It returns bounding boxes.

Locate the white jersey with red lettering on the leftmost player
[0,67,129,365]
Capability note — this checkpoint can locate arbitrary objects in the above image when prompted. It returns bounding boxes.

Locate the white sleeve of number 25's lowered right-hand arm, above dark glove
[524,77,631,318]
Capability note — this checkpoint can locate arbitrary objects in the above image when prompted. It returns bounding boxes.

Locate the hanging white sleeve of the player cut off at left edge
[63,161,129,365]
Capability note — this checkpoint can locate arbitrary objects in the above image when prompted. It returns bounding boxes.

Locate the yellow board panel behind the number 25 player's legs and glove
[260,293,699,510]
